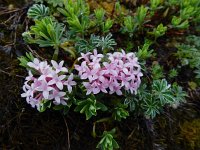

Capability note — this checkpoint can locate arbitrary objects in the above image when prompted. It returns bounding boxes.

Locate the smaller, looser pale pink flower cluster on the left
[21,58,76,110]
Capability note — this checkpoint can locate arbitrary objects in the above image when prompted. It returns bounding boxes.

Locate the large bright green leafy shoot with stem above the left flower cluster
[23,17,65,59]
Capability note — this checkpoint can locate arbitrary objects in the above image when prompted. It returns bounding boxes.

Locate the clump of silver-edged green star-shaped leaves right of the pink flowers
[124,79,187,119]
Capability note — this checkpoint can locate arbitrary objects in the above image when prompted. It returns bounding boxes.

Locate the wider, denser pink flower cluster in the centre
[75,50,143,95]
